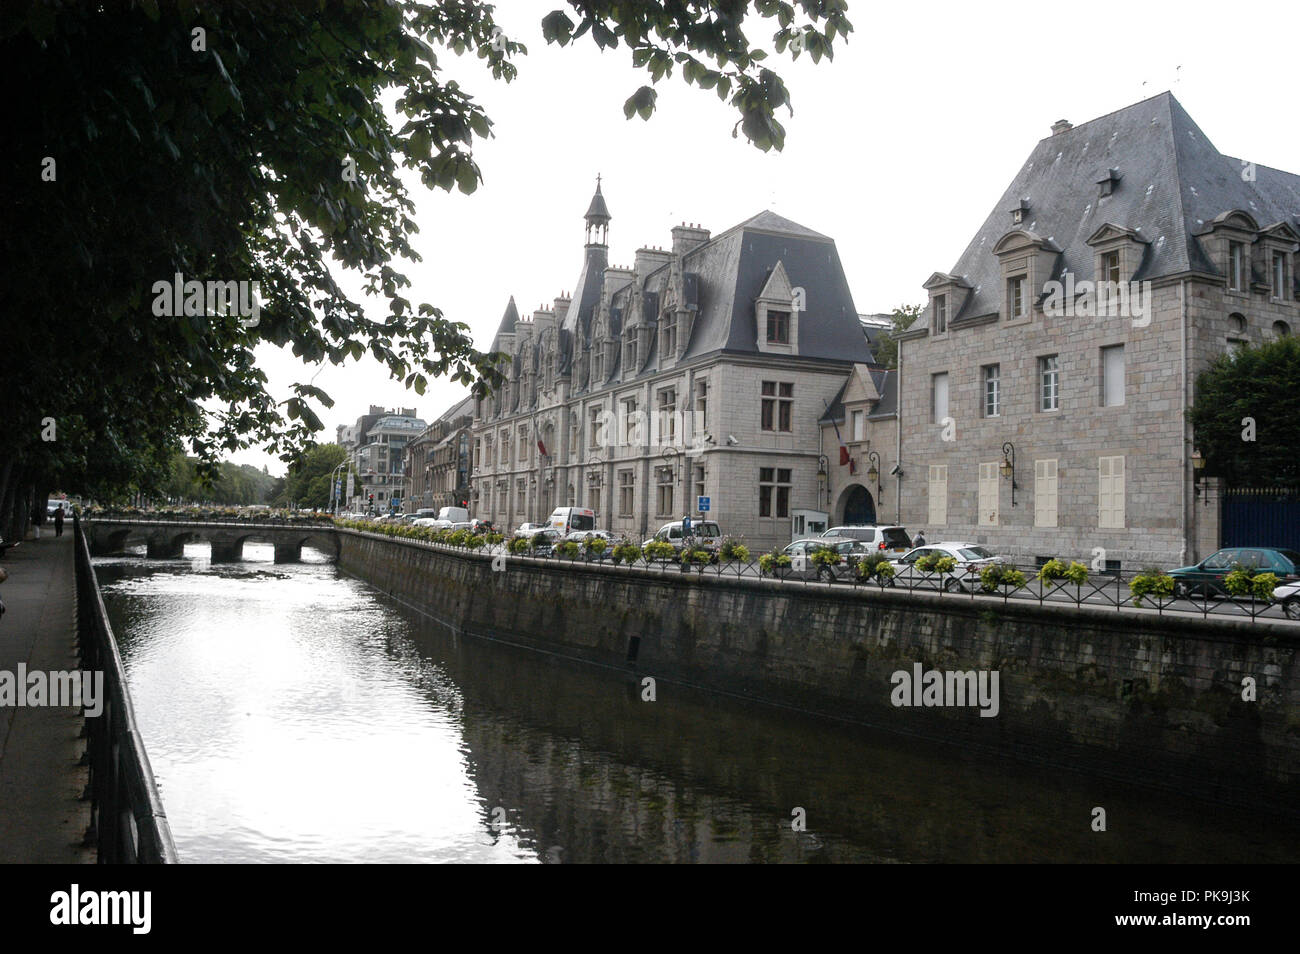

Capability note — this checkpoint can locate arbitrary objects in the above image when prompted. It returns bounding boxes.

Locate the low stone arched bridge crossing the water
[85,517,339,563]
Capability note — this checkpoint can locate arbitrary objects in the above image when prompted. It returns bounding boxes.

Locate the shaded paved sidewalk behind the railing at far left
[0,530,95,863]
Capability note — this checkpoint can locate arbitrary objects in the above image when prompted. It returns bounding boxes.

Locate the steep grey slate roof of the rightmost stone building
[950,92,1300,318]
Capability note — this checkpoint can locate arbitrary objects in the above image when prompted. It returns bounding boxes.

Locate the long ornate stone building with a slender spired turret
[472,183,874,548]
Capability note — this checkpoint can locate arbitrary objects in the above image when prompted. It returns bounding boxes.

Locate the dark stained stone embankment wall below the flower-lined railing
[341,532,1300,815]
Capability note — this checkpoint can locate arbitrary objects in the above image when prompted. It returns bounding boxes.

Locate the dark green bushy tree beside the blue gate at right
[1190,337,1300,487]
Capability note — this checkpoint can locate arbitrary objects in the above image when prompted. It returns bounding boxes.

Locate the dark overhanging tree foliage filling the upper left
[0,0,852,538]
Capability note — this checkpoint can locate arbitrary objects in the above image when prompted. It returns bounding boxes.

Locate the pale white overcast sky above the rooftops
[234,0,1300,473]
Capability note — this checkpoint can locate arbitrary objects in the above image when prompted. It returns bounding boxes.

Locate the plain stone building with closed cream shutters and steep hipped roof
[889,94,1300,569]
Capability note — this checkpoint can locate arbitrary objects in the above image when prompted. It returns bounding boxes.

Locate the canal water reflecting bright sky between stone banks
[95,543,1300,863]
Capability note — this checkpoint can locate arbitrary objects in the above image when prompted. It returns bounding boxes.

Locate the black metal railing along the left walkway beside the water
[73,517,178,864]
